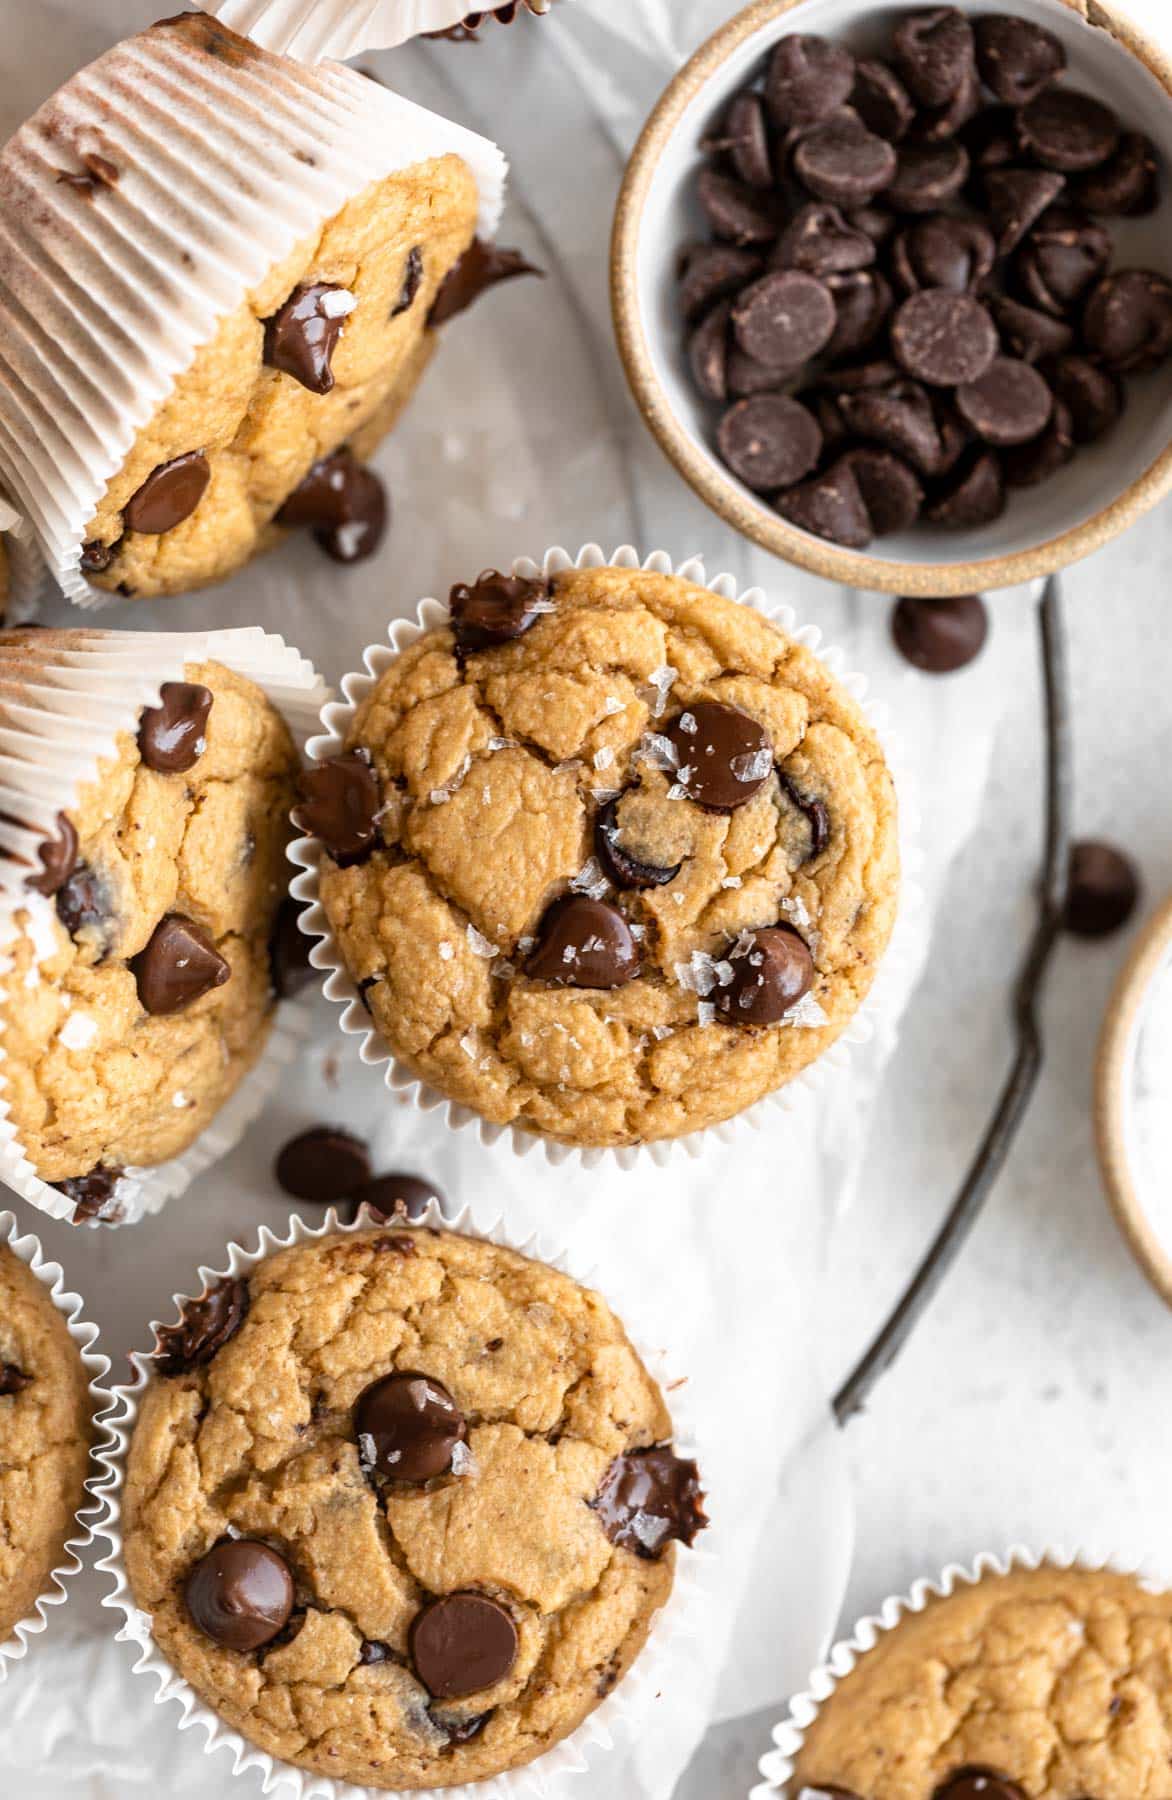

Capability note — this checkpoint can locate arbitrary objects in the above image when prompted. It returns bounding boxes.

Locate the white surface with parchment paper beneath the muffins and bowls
[0,0,1172,1800]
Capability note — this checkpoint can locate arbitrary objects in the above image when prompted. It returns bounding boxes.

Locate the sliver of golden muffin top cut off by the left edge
[0,1246,90,1638]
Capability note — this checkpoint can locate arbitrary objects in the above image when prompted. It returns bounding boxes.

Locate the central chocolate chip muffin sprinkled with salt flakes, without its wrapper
[295,567,898,1147]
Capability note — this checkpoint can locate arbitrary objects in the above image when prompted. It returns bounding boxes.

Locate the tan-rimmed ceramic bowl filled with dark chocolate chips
[612,0,1172,596]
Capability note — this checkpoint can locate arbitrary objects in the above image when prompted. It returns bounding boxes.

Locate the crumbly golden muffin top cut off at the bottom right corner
[789,1568,1172,1800]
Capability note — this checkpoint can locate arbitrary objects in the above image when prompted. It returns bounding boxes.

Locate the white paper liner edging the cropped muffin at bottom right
[749,1544,1168,1800]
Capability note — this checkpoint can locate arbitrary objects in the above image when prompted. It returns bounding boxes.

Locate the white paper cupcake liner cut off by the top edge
[205,0,553,63]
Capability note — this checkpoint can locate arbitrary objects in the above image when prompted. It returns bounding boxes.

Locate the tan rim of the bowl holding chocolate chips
[610,0,1172,598]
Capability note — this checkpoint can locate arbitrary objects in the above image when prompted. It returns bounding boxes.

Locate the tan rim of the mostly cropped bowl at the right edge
[1091,895,1172,1307]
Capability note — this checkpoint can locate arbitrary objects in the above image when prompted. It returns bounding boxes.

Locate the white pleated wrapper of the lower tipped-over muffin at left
[0,626,329,1224]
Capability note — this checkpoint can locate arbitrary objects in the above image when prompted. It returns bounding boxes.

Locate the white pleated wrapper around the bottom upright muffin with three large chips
[95,1201,716,1800]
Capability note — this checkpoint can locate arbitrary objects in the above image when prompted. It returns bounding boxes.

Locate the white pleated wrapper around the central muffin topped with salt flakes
[288,544,924,1170]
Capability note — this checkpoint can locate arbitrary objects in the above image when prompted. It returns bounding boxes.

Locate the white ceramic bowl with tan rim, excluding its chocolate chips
[612,0,1172,594]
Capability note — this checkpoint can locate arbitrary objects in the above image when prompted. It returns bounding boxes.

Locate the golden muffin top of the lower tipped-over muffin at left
[0,648,297,1201]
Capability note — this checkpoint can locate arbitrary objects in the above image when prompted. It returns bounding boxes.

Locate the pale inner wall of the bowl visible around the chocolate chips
[636,0,1172,585]
